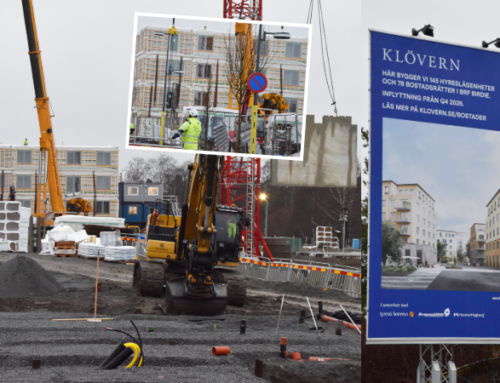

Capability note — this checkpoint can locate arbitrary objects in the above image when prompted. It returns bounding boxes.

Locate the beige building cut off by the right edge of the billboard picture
[485,190,500,269]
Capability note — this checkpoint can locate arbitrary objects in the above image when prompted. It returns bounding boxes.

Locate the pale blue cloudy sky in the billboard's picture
[382,118,500,233]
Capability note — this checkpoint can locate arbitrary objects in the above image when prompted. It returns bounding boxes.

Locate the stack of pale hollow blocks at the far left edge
[0,201,31,253]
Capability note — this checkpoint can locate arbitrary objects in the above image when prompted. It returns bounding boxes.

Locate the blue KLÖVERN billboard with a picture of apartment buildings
[367,31,500,344]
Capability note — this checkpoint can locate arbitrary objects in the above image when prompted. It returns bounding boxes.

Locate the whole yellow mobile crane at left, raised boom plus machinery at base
[22,0,92,226]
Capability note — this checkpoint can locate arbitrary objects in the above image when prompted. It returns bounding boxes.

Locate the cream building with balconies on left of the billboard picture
[382,181,437,248]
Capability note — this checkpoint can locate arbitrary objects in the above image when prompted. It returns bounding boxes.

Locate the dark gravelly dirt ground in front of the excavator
[0,253,361,383]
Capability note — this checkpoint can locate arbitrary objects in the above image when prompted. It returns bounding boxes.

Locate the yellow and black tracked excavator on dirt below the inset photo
[133,154,247,316]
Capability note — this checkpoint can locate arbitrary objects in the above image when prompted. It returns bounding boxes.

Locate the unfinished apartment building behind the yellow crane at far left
[0,145,119,217]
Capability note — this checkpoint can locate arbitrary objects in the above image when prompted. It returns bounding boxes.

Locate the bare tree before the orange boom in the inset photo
[223,23,272,153]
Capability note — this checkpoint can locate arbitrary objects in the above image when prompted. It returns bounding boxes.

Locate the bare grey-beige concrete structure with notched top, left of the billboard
[271,115,358,188]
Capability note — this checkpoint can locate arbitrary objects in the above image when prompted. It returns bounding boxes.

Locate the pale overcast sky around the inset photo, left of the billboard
[0,0,360,174]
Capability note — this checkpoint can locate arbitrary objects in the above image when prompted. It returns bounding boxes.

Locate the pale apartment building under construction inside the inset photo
[132,26,308,116]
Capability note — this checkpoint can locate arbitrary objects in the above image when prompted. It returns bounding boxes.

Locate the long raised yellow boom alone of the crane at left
[22,0,65,219]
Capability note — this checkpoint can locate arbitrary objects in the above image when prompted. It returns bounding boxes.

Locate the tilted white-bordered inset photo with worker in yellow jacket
[126,14,311,160]
